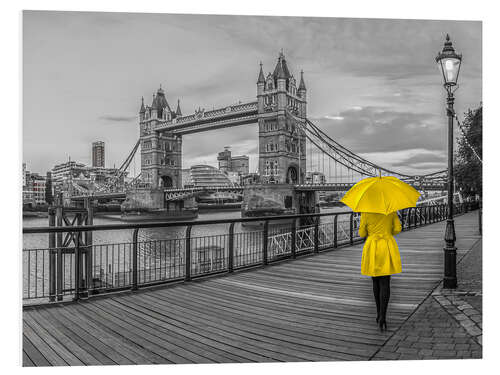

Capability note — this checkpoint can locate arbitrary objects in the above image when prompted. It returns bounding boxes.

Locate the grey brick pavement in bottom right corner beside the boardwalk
[372,240,482,360]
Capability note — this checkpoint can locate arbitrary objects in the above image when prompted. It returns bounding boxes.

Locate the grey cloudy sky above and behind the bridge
[23,11,482,174]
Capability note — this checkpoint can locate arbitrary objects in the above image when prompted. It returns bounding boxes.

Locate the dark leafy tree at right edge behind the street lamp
[454,104,483,198]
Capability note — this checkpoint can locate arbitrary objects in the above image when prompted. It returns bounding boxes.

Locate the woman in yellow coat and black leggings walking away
[359,212,401,331]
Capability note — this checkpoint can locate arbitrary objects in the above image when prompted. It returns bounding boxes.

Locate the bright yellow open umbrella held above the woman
[340,176,420,215]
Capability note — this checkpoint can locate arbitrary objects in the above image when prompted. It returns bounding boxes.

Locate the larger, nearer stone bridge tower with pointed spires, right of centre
[257,52,307,184]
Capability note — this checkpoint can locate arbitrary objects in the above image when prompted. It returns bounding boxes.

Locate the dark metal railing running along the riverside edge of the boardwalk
[23,202,479,304]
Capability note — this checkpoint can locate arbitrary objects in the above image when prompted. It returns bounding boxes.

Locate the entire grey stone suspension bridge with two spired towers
[68,53,447,214]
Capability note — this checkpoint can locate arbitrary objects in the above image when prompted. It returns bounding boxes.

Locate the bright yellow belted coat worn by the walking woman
[359,212,401,276]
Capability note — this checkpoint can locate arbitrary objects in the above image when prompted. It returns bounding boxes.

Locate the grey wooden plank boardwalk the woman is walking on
[23,211,480,366]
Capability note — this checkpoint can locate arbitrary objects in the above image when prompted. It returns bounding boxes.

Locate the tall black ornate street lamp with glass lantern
[436,34,462,289]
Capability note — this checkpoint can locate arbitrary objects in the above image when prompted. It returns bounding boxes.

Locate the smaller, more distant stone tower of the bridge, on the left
[139,86,182,189]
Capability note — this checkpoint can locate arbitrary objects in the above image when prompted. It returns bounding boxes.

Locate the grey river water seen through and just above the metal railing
[22,207,350,303]
